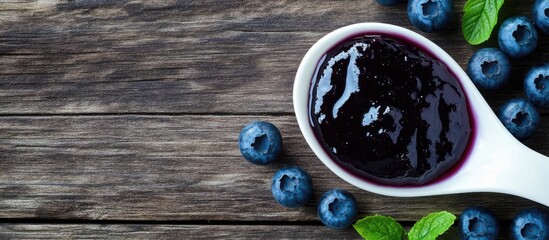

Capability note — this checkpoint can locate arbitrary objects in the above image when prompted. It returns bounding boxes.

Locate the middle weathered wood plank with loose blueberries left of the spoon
[0,115,549,221]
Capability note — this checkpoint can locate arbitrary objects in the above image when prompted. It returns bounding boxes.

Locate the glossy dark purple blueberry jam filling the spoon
[309,35,471,185]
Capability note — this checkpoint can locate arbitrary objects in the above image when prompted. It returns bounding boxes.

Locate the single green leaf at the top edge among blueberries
[461,0,503,45]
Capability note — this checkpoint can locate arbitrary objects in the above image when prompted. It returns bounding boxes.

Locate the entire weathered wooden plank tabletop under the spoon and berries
[0,0,549,239]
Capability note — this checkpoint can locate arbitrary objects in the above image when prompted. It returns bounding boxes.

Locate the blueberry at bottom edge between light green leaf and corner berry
[459,206,499,240]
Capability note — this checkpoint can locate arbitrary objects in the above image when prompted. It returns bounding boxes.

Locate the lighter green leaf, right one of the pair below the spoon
[408,211,456,240]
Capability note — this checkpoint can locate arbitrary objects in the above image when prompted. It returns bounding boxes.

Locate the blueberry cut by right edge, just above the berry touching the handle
[524,63,549,108]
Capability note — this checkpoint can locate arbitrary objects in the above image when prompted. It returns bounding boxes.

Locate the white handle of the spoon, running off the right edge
[448,125,549,206]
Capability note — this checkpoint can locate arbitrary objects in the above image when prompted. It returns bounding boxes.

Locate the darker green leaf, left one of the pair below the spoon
[353,215,406,240]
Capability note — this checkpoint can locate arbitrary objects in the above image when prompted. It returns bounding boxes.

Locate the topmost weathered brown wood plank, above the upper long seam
[0,0,549,115]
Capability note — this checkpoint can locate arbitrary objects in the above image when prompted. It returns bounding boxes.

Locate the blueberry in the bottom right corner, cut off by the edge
[511,208,549,240]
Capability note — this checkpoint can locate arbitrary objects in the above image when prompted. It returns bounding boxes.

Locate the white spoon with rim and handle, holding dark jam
[293,23,549,206]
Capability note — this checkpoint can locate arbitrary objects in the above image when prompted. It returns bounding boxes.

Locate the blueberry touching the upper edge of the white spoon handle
[498,98,540,140]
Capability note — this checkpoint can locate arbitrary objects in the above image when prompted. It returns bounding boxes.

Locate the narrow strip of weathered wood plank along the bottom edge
[0,224,456,240]
